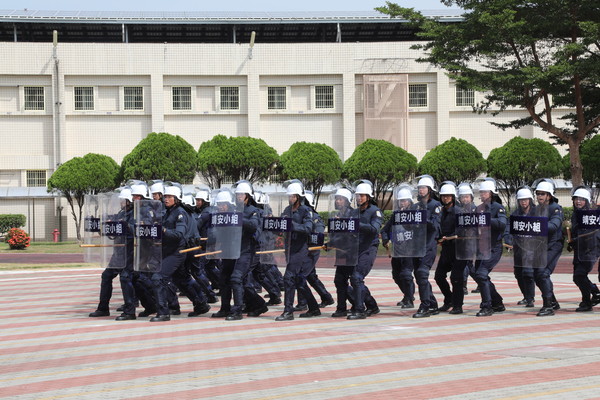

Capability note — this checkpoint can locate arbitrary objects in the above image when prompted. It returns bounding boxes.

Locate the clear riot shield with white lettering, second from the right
[509,212,548,268]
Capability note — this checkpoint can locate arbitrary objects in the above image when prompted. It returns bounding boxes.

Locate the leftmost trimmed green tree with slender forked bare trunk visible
[48,153,120,240]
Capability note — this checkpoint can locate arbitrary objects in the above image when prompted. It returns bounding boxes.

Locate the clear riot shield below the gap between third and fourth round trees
[257,193,292,266]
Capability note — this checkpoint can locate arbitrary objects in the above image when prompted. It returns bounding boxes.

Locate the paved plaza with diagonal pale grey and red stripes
[0,257,600,400]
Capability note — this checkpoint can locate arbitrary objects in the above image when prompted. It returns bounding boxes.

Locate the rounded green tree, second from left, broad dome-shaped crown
[121,132,197,183]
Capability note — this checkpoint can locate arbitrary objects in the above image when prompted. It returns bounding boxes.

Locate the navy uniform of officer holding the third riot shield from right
[473,201,508,310]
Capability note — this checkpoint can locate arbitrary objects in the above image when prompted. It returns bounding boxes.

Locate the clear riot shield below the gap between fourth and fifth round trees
[327,191,360,266]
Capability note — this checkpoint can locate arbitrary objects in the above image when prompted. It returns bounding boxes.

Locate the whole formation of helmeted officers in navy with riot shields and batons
[82,175,600,322]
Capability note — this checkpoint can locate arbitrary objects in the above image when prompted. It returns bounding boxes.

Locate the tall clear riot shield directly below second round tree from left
[133,200,164,272]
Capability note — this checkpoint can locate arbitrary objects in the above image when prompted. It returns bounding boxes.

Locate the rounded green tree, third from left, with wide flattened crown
[197,135,279,188]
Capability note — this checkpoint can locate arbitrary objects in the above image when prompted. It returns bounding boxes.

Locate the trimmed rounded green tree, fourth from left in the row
[280,142,342,203]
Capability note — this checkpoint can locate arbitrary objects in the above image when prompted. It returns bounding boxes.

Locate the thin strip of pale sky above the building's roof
[5,0,460,11]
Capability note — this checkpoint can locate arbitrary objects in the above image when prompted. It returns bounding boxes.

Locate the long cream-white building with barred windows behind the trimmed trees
[0,10,568,240]
